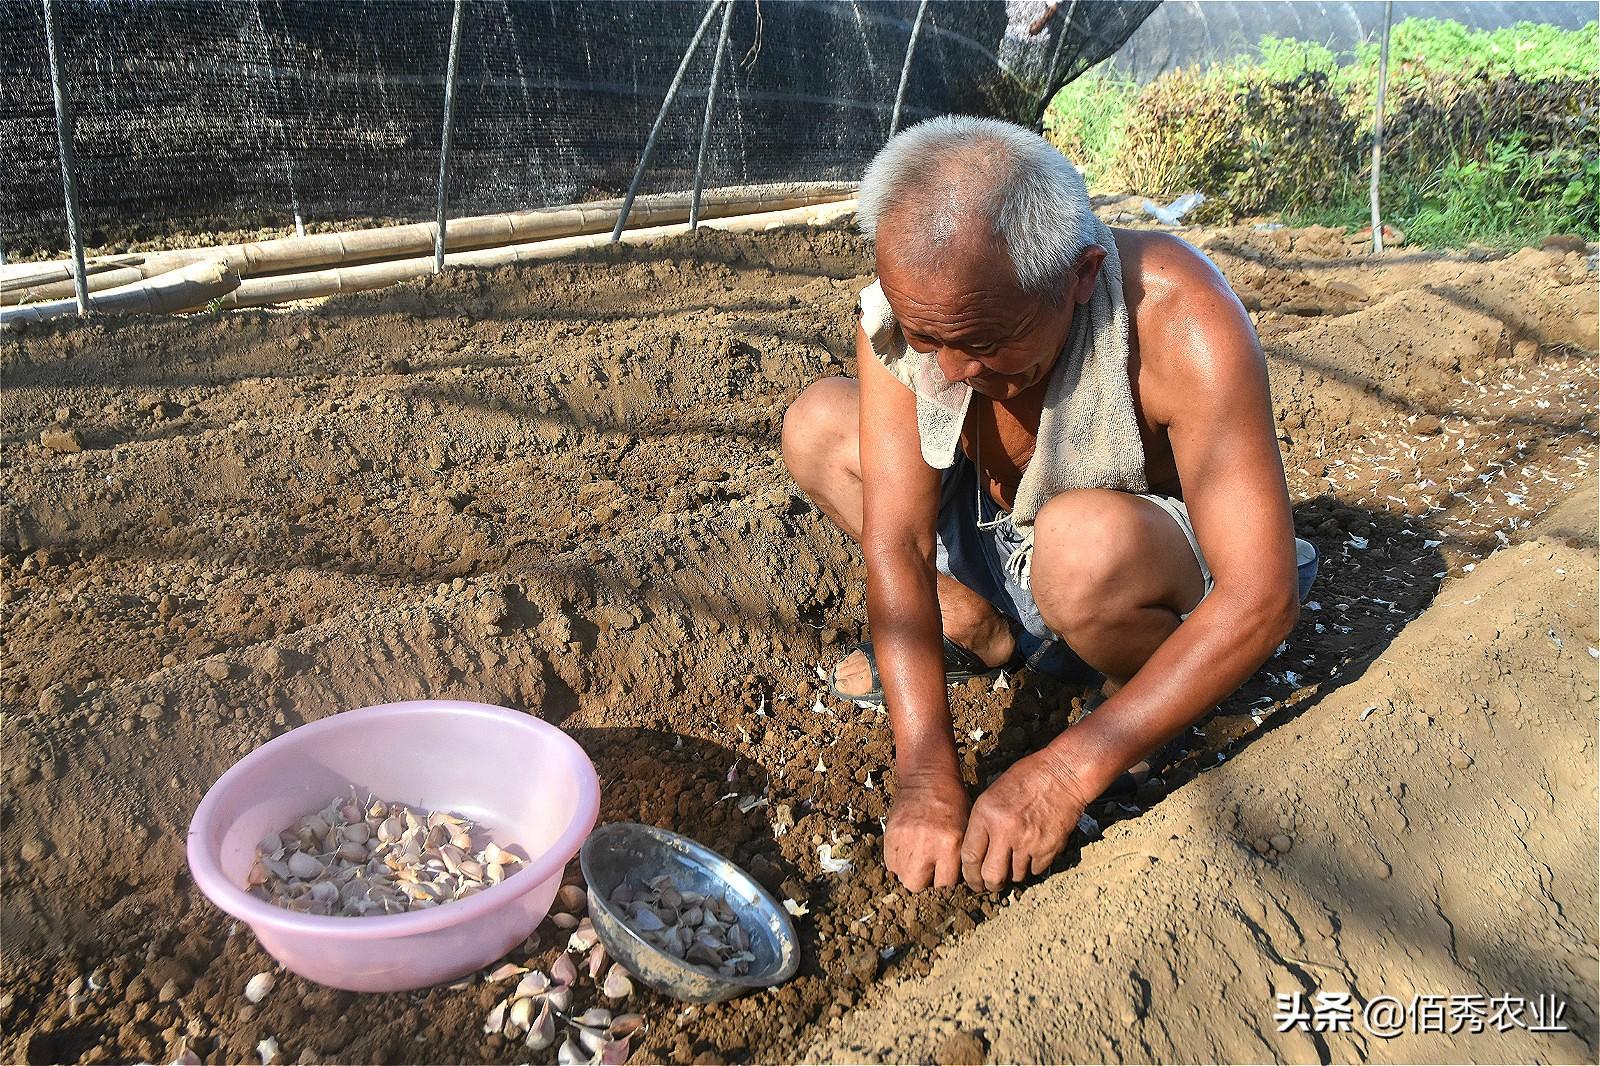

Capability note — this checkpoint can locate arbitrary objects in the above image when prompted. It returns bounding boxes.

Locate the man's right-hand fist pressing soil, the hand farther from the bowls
[962,749,1093,892]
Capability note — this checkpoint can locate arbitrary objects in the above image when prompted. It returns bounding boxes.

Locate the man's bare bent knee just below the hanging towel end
[1032,488,1141,637]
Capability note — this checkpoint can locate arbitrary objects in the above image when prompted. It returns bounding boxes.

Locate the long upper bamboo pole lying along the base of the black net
[0,181,854,288]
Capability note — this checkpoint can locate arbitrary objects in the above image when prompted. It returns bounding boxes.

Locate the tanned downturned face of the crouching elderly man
[877,219,1074,400]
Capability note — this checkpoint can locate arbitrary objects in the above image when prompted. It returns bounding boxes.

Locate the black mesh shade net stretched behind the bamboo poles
[0,0,1157,256]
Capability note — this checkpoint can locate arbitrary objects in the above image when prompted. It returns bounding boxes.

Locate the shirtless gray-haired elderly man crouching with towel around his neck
[782,117,1315,890]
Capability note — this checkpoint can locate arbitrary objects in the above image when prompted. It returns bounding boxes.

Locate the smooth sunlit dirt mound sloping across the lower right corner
[802,483,1597,1063]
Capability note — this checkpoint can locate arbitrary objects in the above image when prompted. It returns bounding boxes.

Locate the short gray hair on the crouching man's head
[856,115,1098,298]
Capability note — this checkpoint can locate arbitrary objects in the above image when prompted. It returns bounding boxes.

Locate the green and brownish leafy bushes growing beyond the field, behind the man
[1045,19,1600,245]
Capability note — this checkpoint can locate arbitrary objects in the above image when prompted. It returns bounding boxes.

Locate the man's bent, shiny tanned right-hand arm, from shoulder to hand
[963,242,1299,887]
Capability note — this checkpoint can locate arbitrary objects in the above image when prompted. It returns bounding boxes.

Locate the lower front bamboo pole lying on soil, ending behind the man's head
[221,200,856,307]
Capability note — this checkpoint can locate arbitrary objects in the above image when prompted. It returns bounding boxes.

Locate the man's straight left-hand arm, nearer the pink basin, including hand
[856,328,968,892]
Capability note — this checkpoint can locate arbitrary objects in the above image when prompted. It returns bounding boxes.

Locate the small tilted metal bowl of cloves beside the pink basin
[579,821,800,1004]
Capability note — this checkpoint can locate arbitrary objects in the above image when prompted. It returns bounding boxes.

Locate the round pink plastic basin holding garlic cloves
[189,699,600,992]
